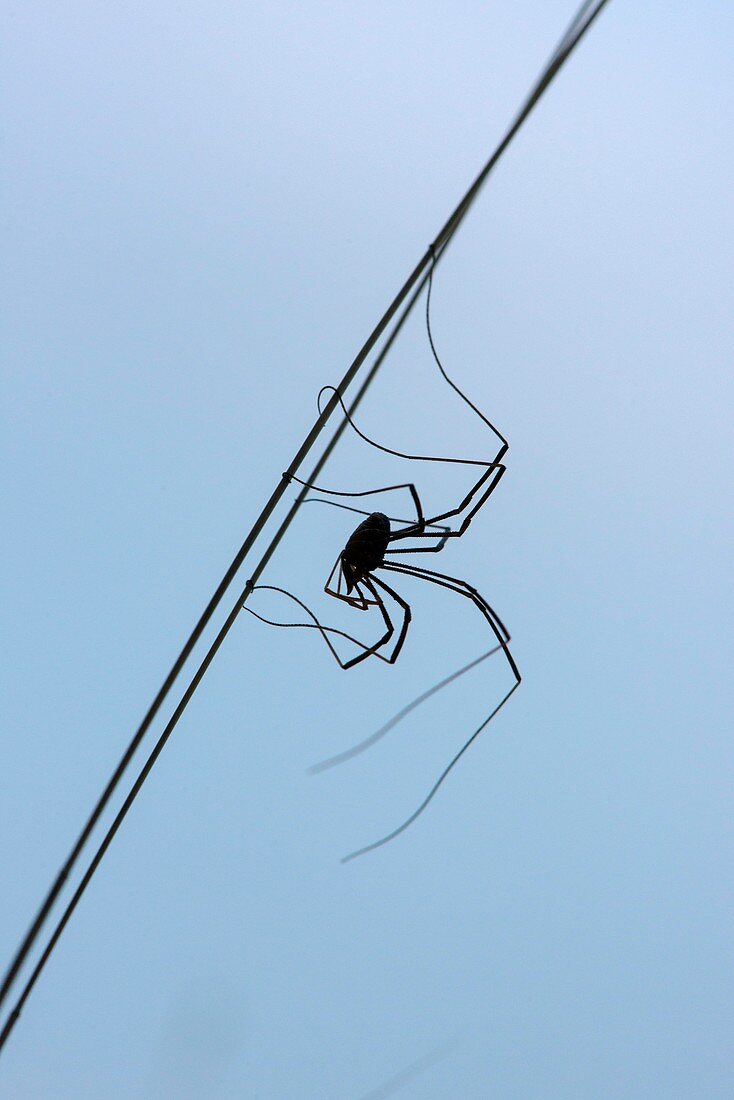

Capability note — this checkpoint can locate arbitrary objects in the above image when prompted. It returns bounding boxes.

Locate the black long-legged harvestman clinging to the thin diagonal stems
[248,271,521,861]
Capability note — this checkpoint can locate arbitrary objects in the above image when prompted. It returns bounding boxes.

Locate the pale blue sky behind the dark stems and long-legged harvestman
[0,0,734,1100]
